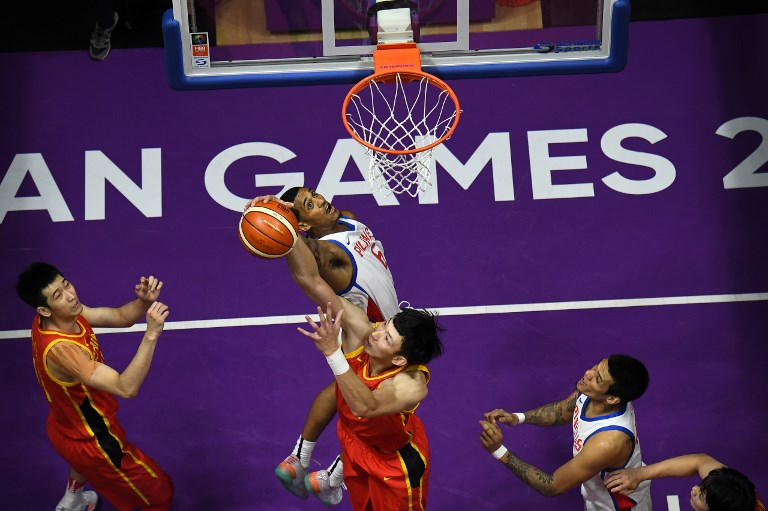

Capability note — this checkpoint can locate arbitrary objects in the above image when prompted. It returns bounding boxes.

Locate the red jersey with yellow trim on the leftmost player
[32,315,119,439]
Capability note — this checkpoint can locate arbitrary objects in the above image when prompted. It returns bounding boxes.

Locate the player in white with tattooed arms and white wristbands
[480,355,651,511]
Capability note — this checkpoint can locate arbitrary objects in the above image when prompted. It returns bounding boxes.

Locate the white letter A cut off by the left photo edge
[0,153,74,223]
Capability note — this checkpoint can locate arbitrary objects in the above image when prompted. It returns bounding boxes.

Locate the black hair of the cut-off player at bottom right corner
[699,467,757,511]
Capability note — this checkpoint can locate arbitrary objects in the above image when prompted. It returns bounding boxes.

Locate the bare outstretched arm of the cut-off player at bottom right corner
[605,454,725,495]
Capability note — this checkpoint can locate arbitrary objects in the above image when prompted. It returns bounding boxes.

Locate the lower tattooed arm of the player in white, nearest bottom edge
[480,422,633,497]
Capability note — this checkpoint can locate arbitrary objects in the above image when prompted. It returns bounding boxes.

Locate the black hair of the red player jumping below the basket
[392,307,444,364]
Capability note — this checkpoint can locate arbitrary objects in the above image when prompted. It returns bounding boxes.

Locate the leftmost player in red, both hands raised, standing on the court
[16,263,173,511]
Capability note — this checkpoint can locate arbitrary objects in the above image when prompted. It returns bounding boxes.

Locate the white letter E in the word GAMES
[528,129,595,199]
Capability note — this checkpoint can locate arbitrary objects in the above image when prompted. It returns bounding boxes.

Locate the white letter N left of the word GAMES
[85,148,163,220]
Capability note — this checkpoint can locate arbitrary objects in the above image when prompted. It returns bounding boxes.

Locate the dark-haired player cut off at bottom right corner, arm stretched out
[605,454,765,511]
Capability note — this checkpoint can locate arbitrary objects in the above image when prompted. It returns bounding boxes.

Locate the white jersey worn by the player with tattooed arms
[573,394,651,511]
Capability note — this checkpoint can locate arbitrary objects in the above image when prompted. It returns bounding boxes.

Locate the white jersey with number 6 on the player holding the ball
[320,217,400,321]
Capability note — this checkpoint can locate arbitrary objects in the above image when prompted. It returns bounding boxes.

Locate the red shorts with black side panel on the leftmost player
[48,421,173,511]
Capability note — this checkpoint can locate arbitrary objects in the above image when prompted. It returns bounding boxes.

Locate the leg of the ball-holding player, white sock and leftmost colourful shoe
[275,382,336,499]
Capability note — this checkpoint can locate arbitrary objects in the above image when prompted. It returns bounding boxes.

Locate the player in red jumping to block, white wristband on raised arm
[286,238,443,511]
